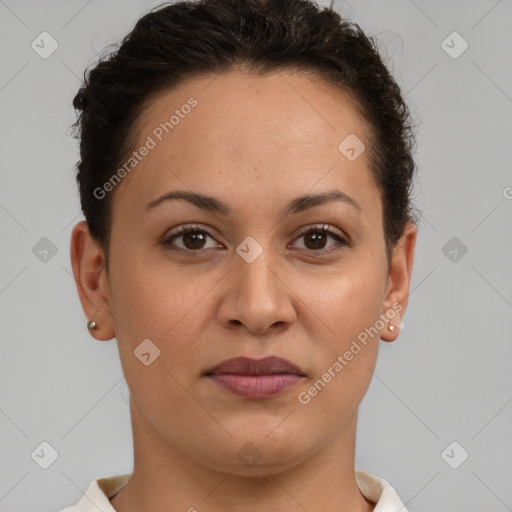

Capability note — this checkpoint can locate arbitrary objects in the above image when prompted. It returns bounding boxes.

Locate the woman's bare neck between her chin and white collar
[111,404,374,512]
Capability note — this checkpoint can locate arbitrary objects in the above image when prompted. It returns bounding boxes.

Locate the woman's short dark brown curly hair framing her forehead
[73,0,416,267]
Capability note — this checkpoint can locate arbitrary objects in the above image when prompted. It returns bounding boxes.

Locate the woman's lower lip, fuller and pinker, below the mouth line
[209,373,302,398]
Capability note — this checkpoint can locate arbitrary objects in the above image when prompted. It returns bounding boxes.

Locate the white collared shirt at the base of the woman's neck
[61,470,407,512]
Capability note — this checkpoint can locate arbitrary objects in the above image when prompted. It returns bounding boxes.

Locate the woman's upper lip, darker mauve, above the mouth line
[206,356,305,376]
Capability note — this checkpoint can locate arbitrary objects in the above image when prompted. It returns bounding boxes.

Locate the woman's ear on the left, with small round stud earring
[70,221,115,341]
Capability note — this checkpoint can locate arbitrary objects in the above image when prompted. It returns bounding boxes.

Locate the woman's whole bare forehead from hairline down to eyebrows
[110,67,375,218]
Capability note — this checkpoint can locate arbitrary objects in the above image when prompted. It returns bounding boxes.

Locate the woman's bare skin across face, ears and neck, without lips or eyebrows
[71,70,417,512]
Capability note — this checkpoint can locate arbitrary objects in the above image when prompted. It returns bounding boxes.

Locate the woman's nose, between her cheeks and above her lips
[218,244,297,335]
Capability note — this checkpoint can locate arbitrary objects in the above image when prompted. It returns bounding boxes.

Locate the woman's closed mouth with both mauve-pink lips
[205,356,306,398]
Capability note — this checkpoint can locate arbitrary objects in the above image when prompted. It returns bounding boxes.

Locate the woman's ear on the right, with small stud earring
[380,222,418,341]
